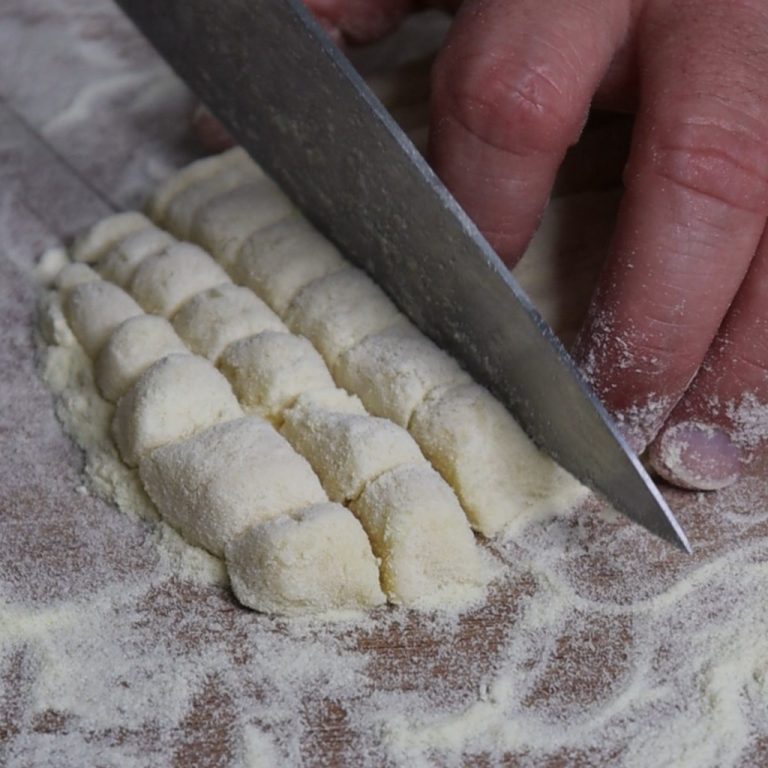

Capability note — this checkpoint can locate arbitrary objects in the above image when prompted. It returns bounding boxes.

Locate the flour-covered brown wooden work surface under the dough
[0,0,768,767]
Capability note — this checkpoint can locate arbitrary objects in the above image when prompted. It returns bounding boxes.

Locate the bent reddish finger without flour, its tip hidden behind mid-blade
[429,0,629,263]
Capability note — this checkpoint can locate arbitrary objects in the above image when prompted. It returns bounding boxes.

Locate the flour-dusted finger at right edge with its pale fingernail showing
[649,233,768,490]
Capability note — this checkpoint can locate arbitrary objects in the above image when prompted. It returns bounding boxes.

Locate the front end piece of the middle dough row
[351,462,489,607]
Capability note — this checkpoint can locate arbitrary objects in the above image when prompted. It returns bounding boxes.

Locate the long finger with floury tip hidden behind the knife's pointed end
[577,0,768,449]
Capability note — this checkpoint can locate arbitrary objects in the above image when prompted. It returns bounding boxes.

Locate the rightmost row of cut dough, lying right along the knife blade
[154,150,588,536]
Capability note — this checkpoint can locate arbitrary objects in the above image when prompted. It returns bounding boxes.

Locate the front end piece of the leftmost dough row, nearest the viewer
[226,504,384,616]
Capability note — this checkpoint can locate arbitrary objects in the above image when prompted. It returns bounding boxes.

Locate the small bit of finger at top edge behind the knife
[304,0,413,43]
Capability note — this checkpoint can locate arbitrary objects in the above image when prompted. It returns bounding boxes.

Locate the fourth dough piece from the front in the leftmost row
[94,314,187,403]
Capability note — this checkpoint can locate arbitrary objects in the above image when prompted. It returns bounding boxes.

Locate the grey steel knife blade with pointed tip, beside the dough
[112,0,691,552]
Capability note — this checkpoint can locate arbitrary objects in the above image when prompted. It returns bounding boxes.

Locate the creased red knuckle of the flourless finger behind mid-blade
[432,55,582,155]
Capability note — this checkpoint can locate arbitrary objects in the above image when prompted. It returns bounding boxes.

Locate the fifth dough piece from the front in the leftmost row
[64,280,144,357]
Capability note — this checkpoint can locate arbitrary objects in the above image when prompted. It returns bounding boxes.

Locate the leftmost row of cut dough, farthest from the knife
[45,260,385,615]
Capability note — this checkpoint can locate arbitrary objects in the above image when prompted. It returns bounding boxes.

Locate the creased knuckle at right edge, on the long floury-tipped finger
[651,107,768,215]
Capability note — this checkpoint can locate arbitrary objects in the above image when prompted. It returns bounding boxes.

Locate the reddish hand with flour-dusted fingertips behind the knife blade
[198,0,768,489]
